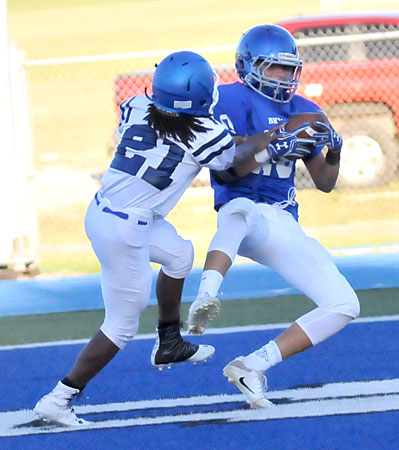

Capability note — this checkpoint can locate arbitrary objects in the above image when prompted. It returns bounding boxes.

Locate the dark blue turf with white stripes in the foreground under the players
[0,320,399,450]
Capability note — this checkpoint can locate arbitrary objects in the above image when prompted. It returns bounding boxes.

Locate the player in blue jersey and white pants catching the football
[188,25,359,408]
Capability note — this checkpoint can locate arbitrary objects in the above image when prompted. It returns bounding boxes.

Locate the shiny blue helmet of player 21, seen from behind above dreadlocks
[152,51,218,116]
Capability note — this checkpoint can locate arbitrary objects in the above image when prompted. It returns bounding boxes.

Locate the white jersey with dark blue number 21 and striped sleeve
[101,95,235,217]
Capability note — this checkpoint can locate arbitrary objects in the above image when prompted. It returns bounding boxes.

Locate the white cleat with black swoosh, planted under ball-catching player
[223,356,274,408]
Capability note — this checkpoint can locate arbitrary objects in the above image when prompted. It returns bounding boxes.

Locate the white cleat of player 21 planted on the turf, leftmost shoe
[34,381,90,427]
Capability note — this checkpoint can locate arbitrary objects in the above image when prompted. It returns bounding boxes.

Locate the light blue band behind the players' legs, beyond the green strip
[0,252,399,317]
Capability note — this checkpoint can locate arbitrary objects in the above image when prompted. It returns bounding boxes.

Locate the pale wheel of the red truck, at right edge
[337,119,399,188]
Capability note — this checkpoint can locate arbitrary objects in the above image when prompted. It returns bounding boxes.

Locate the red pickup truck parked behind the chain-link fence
[115,11,399,187]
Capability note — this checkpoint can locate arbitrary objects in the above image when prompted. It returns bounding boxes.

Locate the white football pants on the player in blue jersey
[208,198,360,344]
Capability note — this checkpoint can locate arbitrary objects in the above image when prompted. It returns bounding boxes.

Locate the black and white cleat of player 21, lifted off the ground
[151,324,215,370]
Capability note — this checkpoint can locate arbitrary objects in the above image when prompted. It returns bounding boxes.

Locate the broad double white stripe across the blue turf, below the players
[0,379,399,437]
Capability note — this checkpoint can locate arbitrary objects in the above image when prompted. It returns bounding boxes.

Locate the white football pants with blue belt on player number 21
[85,199,194,348]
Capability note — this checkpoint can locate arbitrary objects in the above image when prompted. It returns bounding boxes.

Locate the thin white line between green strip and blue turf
[0,314,399,351]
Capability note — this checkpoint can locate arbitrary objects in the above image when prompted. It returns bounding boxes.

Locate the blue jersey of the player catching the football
[211,82,322,220]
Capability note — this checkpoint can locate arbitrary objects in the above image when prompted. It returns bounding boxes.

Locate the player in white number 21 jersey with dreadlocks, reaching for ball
[35,52,292,426]
